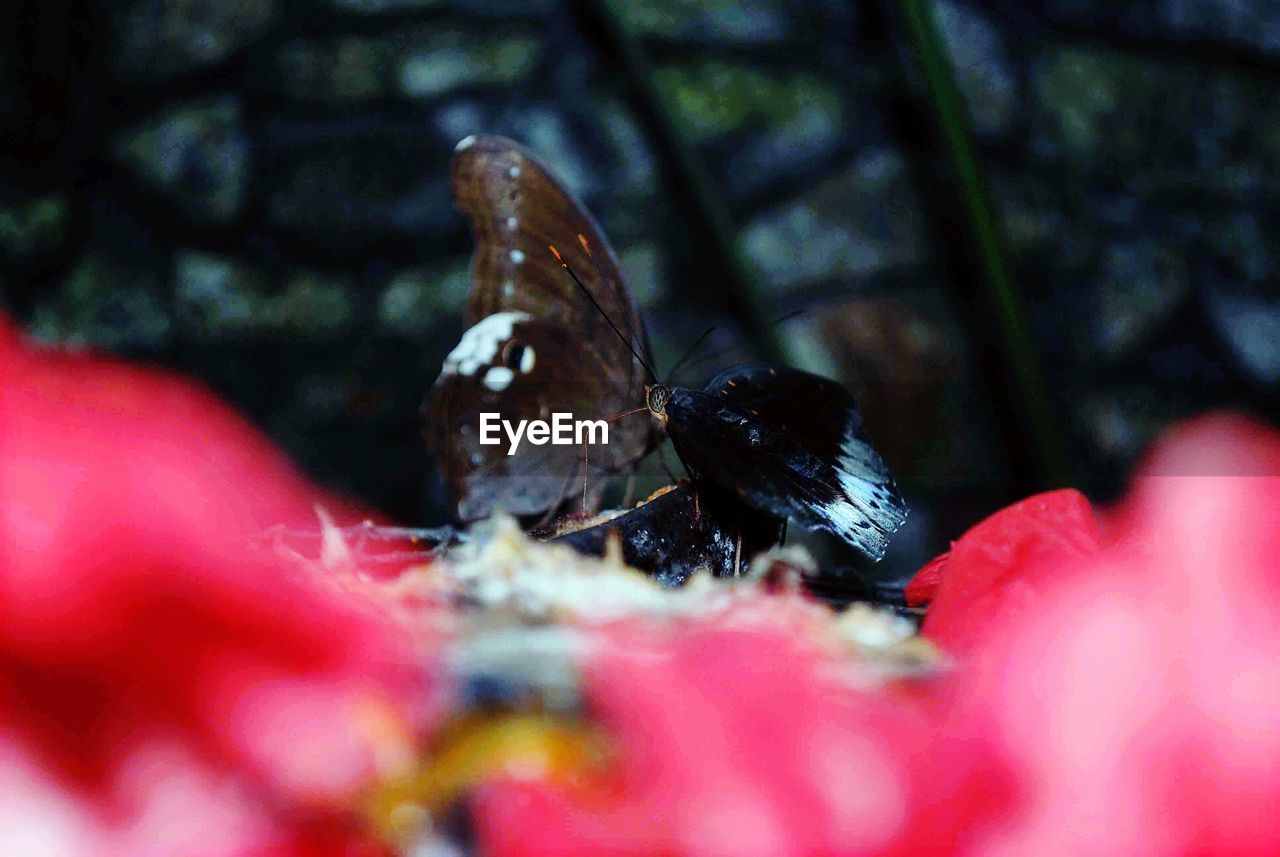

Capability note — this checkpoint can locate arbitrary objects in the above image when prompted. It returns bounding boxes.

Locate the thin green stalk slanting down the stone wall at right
[899,0,1068,485]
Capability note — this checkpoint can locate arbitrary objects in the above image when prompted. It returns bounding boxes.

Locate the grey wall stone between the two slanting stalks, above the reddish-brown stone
[742,148,925,293]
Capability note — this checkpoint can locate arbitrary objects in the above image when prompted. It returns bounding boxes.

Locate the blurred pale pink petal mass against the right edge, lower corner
[966,416,1280,854]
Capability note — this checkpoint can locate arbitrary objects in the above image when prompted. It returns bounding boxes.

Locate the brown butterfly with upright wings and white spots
[422,137,662,521]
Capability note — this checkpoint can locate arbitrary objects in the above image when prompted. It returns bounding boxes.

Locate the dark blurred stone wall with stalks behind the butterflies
[0,0,1280,578]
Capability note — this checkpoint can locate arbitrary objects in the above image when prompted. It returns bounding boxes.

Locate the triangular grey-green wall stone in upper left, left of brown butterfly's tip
[115,96,250,223]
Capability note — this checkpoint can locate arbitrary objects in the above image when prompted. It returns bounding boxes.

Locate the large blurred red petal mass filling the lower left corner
[0,317,403,854]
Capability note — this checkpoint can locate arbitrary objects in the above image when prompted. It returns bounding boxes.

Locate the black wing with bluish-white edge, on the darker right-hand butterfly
[667,365,906,559]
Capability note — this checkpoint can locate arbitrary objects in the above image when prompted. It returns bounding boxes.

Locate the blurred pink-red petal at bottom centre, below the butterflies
[479,619,1007,856]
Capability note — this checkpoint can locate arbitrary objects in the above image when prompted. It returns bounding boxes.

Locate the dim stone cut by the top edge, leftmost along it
[115,0,275,77]
